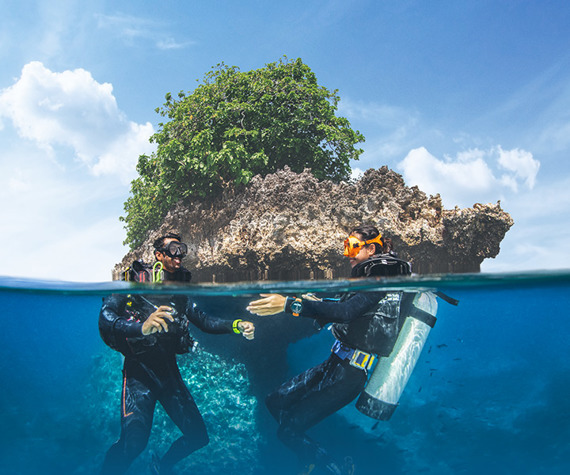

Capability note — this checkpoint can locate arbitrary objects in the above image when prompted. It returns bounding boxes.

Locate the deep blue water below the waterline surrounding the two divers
[0,271,570,475]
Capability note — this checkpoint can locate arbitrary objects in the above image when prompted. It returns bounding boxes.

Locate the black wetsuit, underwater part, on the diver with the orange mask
[266,292,413,473]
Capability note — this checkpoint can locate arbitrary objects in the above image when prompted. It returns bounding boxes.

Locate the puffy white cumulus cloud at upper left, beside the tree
[0,61,154,183]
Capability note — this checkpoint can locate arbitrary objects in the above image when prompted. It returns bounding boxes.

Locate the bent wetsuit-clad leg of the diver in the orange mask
[266,355,366,473]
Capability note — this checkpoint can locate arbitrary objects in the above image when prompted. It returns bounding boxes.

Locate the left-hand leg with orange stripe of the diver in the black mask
[101,362,156,475]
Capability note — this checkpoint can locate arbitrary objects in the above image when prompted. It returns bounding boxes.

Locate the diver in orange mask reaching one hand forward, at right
[247,225,413,475]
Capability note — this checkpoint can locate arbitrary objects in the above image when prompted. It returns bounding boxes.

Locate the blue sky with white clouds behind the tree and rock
[0,0,570,281]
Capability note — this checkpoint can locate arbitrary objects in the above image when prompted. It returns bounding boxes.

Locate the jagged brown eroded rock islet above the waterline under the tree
[114,167,513,282]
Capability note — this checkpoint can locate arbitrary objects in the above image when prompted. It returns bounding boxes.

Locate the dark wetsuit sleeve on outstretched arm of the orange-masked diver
[285,292,386,323]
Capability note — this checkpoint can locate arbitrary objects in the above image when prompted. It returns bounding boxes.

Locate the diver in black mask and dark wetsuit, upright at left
[99,233,255,474]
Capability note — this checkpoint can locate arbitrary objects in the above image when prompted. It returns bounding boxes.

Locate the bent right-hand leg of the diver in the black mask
[153,371,210,473]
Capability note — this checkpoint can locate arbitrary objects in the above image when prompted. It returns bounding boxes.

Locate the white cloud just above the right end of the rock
[398,146,540,208]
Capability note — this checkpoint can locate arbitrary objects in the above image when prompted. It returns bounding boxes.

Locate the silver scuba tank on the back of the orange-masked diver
[356,292,437,421]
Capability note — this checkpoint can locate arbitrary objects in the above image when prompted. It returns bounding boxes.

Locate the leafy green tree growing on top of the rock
[121,58,364,247]
